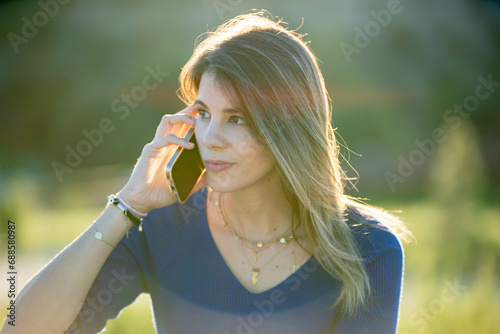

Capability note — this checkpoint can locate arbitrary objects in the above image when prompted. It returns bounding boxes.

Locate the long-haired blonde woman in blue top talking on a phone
[2,12,410,334]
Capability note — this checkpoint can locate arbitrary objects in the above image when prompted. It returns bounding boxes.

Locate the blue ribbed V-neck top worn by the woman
[66,188,404,334]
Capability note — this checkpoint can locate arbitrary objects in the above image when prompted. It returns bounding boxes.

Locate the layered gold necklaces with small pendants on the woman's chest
[215,193,295,285]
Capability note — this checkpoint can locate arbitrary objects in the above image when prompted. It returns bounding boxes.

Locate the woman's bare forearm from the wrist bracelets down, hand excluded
[0,205,132,334]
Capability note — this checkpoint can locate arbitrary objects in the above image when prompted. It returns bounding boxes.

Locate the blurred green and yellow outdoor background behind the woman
[0,0,500,334]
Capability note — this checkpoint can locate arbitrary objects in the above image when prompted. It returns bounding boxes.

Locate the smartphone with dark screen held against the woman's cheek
[165,127,205,203]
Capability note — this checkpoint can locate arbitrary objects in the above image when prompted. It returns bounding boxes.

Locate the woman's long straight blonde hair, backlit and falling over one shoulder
[178,11,411,313]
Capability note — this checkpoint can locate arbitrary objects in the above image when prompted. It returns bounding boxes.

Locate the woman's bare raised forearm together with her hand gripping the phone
[0,106,199,334]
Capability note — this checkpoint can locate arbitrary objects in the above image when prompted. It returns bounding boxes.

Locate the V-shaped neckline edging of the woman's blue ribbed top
[200,186,314,297]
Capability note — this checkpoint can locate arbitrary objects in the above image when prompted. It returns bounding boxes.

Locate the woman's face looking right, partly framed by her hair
[194,72,275,192]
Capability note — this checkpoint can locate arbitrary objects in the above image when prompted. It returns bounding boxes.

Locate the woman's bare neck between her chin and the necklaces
[217,170,293,241]
